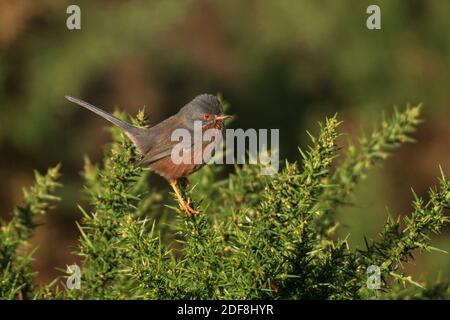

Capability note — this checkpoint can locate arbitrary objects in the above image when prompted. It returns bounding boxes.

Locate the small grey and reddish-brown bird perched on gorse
[65,94,233,215]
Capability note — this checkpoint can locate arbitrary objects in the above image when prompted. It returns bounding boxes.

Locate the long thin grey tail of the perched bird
[66,96,147,152]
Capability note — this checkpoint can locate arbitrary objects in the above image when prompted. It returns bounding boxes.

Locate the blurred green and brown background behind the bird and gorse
[0,0,450,282]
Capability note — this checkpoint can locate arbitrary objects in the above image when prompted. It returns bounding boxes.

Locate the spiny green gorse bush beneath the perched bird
[0,103,450,299]
